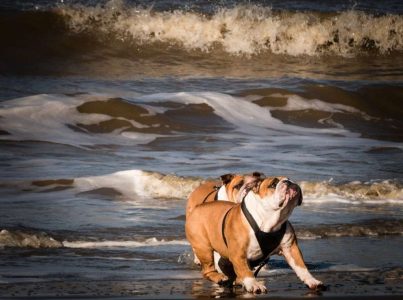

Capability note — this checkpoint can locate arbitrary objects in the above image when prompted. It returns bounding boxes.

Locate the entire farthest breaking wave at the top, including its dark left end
[0,0,403,58]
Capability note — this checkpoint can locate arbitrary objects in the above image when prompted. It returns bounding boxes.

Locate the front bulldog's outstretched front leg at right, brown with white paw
[282,239,323,289]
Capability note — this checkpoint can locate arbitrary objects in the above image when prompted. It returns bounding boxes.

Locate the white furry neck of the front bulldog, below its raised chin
[244,191,289,232]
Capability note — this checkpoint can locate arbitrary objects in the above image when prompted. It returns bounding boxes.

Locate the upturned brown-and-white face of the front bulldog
[254,177,302,210]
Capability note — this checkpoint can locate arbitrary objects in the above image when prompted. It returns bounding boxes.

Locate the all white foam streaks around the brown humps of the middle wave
[0,92,378,147]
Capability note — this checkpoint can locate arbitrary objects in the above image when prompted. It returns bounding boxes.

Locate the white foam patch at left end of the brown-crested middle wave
[0,94,158,147]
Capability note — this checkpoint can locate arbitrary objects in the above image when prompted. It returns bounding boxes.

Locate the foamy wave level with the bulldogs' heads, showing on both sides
[23,170,403,205]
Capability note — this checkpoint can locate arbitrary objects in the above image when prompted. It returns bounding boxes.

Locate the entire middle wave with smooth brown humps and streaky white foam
[0,88,401,147]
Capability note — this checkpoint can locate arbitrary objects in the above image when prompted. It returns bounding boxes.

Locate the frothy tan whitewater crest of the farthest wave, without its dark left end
[57,1,403,56]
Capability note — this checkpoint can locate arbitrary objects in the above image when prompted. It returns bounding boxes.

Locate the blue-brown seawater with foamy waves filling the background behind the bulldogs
[0,0,403,296]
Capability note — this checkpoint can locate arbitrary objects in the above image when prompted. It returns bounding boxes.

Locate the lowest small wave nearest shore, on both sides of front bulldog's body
[0,219,403,249]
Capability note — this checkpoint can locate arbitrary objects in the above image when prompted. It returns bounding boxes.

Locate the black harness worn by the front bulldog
[218,200,288,277]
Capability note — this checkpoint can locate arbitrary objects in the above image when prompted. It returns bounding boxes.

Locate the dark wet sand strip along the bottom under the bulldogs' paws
[0,268,403,299]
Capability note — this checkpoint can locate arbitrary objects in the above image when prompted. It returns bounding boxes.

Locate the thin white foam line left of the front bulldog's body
[63,238,189,248]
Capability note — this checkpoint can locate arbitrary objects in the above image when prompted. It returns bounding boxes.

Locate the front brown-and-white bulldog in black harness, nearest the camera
[185,177,322,293]
